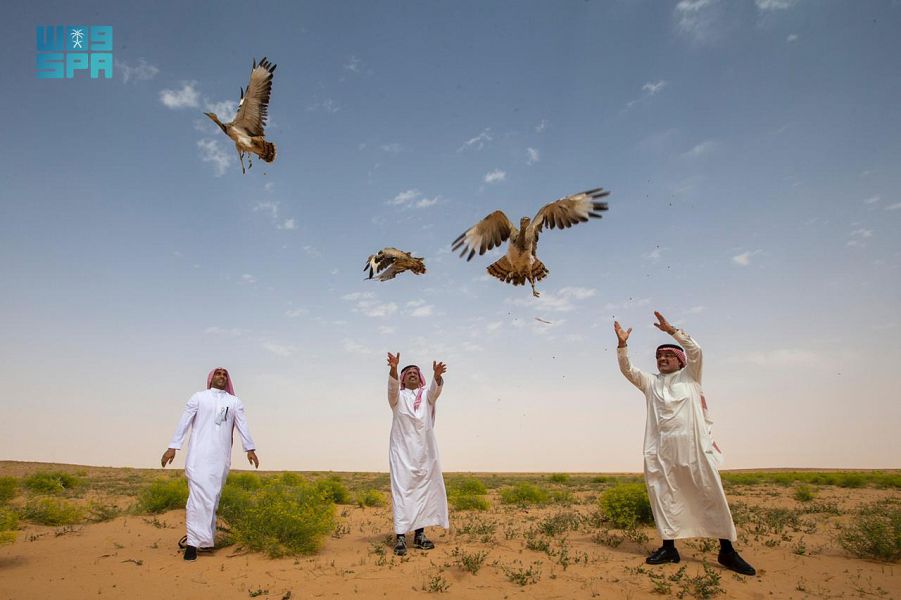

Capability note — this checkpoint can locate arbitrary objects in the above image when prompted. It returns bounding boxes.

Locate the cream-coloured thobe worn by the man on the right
[617,329,736,541]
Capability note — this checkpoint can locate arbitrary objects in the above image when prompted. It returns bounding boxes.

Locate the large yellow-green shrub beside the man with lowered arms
[219,478,335,558]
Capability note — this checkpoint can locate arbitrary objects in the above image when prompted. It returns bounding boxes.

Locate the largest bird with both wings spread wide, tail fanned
[451,188,610,298]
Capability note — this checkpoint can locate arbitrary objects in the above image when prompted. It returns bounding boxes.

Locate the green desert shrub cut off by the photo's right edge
[838,502,901,562]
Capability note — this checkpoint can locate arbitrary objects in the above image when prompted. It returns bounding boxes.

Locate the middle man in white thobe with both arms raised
[388,352,449,556]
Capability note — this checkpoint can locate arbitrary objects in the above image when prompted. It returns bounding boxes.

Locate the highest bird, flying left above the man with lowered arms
[203,56,276,173]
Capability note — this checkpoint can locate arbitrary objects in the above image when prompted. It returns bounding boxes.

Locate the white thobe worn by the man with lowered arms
[169,388,256,548]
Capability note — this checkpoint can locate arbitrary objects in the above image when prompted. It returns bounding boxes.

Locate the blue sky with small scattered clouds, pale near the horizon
[0,0,901,471]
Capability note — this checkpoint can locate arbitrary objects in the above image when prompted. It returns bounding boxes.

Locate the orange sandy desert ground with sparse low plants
[0,462,901,600]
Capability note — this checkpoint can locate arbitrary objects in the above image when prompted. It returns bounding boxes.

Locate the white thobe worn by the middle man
[388,376,449,533]
